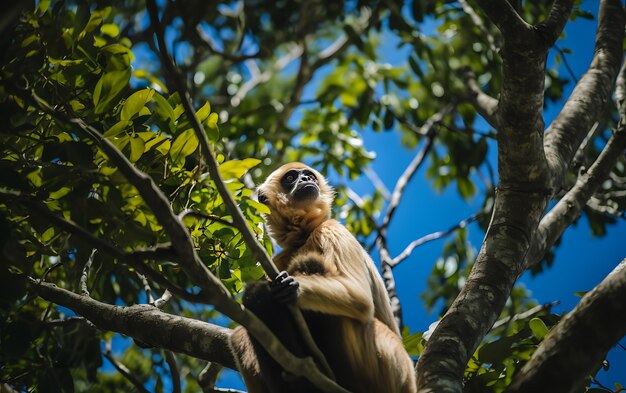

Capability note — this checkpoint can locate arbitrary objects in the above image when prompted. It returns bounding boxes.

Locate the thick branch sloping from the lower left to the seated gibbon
[31,279,237,370]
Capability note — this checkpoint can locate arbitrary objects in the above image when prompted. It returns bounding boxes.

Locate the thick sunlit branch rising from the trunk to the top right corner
[544,0,624,192]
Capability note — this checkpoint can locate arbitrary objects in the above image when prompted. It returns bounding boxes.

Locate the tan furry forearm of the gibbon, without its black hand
[294,275,374,321]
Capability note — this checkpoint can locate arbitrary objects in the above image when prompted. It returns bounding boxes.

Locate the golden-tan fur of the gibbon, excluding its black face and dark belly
[231,163,416,393]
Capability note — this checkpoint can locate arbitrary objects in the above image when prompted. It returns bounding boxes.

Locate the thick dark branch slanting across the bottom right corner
[507,259,626,393]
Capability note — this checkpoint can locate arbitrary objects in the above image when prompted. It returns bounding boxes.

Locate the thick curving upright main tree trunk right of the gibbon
[417,0,572,392]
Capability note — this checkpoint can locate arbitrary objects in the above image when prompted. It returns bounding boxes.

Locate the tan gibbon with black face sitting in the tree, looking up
[231,163,417,393]
